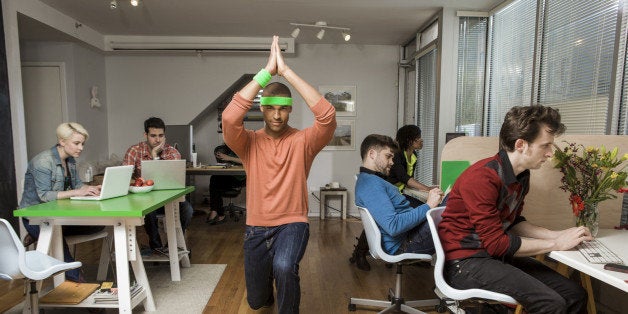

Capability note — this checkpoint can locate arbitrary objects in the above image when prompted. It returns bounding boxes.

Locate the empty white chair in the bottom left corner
[0,219,81,313]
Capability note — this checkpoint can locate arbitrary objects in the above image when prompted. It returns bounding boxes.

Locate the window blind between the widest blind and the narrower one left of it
[486,0,537,136]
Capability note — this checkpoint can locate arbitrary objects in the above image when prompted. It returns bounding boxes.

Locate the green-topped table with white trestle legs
[13,187,194,313]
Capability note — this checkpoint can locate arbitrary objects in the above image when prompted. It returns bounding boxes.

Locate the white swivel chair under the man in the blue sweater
[349,206,440,313]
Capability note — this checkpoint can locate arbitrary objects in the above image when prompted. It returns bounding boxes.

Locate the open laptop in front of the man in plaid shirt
[142,159,185,190]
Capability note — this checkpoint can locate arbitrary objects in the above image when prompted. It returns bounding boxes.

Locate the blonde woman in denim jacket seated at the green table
[20,122,104,281]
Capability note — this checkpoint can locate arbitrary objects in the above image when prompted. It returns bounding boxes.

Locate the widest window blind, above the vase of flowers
[539,0,618,134]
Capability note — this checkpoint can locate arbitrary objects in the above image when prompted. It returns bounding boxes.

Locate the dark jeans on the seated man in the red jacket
[444,257,587,313]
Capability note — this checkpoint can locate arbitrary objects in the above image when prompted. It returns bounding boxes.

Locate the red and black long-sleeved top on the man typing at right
[438,150,530,261]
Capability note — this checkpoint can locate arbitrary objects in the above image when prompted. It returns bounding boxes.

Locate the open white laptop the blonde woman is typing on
[70,165,133,201]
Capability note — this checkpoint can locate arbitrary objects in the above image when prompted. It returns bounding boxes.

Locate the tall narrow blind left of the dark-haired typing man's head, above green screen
[456,17,488,136]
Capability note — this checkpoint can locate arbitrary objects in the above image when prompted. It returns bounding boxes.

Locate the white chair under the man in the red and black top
[427,206,522,314]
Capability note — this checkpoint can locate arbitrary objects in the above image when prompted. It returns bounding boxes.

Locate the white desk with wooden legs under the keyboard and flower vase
[549,229,628,314]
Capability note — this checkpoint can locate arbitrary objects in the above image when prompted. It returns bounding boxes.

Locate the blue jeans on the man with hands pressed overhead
[244,222,310,314]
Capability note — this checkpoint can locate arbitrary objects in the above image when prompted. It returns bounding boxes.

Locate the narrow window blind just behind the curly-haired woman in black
[414,49,436,185]
